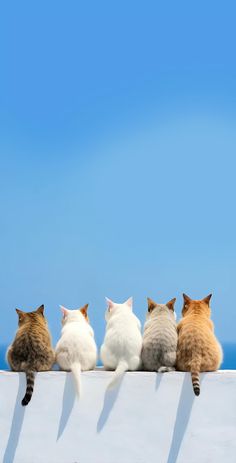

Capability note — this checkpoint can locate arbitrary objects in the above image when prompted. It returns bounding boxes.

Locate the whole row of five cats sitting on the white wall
[6,294,223,405]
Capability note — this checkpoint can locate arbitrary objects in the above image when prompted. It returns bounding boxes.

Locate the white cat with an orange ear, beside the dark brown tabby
[56,304,97,397]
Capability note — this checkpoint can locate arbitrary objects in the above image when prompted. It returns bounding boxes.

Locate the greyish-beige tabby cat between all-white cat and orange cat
[141,298,177,373]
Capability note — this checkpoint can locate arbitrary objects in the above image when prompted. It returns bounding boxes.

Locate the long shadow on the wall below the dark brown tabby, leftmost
[2,373,26,463]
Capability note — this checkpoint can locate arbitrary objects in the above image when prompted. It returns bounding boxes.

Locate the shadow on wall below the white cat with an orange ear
[57,373,76,441]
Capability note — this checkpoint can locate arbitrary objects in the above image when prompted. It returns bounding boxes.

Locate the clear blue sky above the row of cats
[0,0,236,344]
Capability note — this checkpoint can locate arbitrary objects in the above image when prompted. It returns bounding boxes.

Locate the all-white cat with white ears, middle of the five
[100,298,142,389]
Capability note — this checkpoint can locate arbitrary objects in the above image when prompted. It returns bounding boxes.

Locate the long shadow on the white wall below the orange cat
[167,373,199,463]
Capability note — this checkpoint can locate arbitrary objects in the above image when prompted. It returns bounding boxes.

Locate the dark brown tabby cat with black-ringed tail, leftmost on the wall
[6,305,55,406]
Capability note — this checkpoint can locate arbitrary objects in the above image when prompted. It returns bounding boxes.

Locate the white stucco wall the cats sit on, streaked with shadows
[0,370,236,463]
